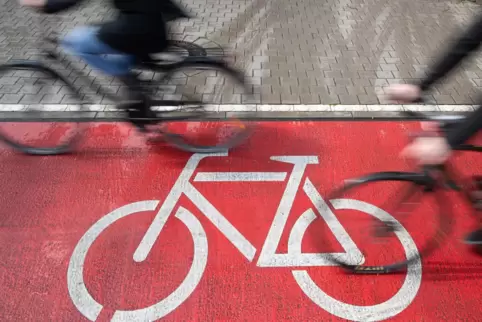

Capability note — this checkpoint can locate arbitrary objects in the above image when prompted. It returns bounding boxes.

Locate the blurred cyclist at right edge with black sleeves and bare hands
[388,13,482,245]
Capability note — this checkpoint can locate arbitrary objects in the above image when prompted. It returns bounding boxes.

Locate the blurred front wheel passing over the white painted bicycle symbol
[317,172,452,274]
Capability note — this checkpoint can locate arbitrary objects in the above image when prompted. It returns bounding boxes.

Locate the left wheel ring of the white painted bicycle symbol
[67,200,208,321]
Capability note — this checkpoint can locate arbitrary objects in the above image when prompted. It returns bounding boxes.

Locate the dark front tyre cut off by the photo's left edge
[0,61,85,156]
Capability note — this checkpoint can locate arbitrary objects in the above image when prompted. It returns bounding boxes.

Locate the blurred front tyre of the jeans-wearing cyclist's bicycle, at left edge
[0,61,83,155]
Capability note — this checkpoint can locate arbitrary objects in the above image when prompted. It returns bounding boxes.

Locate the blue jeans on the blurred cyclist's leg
[61,26,135,76]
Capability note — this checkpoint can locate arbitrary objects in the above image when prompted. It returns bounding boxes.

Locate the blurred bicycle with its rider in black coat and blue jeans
[0,0,252,155]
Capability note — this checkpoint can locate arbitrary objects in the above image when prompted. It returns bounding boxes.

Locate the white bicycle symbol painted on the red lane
[67,153,422,321]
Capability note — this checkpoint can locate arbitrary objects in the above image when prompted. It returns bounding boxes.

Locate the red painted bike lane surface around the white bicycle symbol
[0,121,482,321]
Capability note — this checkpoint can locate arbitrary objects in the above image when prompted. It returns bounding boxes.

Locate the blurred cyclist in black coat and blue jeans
[19,0,189,127]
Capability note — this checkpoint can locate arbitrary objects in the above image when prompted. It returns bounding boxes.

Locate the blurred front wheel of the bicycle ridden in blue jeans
[0,61,82,155]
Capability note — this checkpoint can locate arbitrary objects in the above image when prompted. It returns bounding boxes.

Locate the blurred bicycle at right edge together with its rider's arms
[322,9,482,274]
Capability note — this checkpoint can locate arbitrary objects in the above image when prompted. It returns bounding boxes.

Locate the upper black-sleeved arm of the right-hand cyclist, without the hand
[418,13,482,91]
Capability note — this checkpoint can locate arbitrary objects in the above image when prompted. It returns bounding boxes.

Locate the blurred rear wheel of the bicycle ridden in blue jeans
[145,58,253,153]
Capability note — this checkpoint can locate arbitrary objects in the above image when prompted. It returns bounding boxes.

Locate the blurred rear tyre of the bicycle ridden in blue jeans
[147,57,254,153]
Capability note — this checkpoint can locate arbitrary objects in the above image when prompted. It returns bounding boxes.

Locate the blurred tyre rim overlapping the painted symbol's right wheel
[320,172,452,274]
